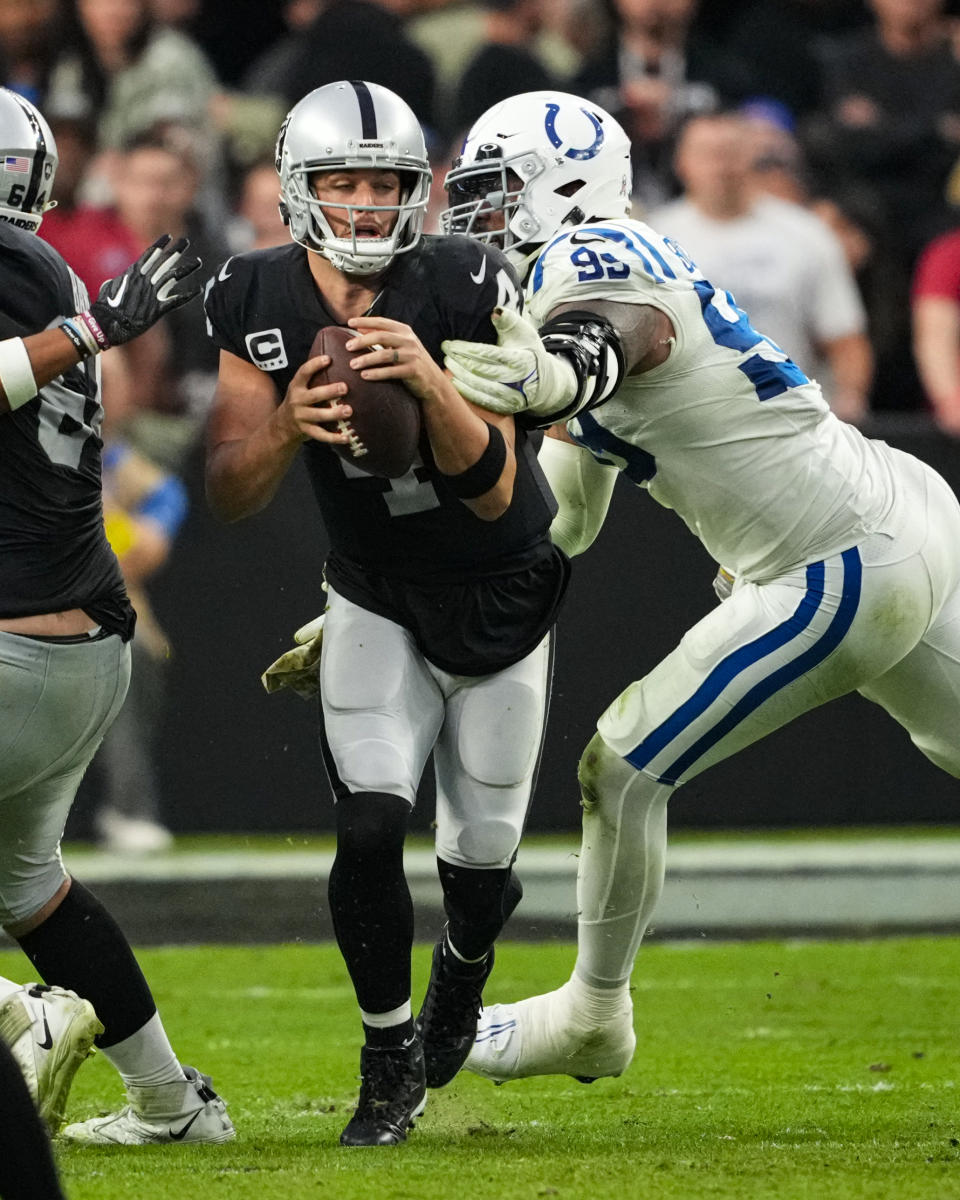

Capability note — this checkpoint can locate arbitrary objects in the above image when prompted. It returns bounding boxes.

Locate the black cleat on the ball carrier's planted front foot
[340,1036,427,1146]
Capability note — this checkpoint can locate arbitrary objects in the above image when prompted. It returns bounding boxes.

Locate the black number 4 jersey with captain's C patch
[205,236,556,578]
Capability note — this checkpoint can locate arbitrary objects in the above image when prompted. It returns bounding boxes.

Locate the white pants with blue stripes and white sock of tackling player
[576,456,960,986]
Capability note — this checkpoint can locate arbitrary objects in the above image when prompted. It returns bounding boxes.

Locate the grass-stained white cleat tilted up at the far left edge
[0,983,103,1134]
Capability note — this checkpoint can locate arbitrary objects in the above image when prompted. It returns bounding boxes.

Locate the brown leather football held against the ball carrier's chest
[310,325,420,479]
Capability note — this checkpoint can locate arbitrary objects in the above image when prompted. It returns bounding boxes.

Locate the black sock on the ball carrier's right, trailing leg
[437,858,523,959]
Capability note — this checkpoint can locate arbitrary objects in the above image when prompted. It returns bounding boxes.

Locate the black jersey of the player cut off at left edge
[0,221,134,638]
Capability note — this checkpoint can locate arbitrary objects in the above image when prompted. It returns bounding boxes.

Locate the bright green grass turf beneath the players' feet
[9,938,960,1200]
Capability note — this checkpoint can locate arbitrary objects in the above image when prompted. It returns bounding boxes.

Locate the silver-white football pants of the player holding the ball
[320,588,551,868]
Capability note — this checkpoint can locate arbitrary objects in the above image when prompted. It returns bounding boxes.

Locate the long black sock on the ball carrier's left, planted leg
[328,792,413,1013]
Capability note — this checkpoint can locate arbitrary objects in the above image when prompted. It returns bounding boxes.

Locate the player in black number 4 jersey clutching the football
[205,82,568,1146]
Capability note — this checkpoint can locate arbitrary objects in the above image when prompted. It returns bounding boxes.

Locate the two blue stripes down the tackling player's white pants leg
[625,547,862,785]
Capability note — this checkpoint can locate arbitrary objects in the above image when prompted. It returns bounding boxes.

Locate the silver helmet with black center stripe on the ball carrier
[276,80,431,275]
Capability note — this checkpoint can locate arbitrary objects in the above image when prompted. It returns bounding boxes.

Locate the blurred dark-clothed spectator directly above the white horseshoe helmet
[450,0,554,133]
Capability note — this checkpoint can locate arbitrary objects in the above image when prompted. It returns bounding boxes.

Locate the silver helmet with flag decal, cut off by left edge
[0,88,60,233]
